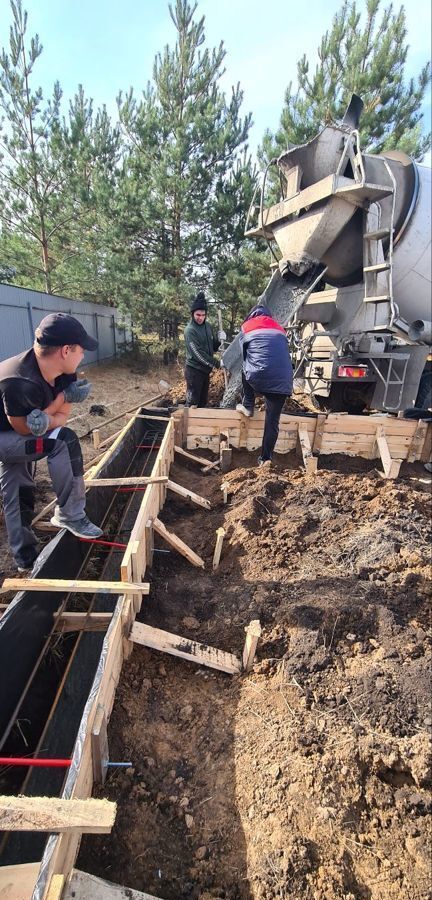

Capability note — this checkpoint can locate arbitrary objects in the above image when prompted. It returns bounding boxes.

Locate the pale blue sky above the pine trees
[0,0,431,158]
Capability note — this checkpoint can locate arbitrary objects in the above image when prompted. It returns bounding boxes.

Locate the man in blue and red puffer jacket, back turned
[236,306,293,465]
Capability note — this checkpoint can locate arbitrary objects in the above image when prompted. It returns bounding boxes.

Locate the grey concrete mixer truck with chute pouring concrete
[223,95,432,412]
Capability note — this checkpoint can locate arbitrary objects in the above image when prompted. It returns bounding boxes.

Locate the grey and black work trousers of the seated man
[0,428,85,568]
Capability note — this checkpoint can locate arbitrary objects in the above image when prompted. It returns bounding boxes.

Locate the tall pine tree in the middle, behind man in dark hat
[117,0,251,334]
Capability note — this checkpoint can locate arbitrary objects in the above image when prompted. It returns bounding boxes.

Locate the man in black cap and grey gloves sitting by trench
[0,313,102,571]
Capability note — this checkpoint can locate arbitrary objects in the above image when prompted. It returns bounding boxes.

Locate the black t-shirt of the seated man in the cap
[0,350,76,431]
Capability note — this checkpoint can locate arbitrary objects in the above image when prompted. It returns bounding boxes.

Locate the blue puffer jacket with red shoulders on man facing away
[240,306,293,395]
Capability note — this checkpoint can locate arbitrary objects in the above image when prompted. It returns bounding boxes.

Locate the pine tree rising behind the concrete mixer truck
[260,0,431,168]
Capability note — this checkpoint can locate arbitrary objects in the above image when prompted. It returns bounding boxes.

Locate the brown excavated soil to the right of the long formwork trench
[78,452,432,900]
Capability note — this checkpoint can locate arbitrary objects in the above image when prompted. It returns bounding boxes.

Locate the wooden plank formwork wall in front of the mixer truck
[182,409,432,478]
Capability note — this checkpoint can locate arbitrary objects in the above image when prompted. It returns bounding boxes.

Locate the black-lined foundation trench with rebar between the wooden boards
[0,411,166,865]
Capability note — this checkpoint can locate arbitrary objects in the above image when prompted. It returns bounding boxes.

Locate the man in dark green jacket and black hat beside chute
[184,291,220,406]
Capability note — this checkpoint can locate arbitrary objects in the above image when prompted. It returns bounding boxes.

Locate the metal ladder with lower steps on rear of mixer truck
[363,160,410,412]
